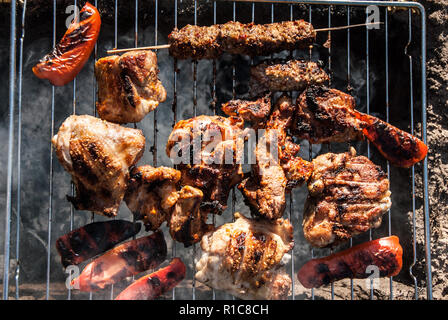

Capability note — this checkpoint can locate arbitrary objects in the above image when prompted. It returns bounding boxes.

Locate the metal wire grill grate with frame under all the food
[3,0,432,299]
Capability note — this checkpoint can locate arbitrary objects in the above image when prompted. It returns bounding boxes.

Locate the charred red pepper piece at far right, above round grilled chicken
[357,112,428,168]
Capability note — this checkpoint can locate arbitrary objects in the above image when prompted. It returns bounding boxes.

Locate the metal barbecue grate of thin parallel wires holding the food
[3,0,432,300]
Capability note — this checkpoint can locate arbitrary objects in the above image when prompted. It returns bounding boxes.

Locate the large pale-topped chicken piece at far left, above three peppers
[52,115,145,217]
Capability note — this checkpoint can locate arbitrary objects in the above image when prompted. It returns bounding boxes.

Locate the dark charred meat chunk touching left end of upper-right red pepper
[292,86,363,143]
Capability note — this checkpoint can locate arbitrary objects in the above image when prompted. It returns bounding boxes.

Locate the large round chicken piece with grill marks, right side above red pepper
[303,148,391,248]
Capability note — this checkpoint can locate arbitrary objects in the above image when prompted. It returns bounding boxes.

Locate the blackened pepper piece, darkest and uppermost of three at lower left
[56,220,141,268]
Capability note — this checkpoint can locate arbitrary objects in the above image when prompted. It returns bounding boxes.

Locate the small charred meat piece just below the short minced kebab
[221,94,271,127]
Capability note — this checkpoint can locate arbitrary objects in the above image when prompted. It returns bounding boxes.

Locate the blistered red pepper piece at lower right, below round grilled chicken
[297,236,403,288]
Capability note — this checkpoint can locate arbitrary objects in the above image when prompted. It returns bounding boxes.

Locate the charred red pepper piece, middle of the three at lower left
[72,231,167,291]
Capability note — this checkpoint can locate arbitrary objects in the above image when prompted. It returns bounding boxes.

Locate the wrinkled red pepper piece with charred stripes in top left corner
[33,2,101,86]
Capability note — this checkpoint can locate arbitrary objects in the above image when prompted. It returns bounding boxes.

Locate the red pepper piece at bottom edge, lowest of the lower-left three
[115,258,186,300]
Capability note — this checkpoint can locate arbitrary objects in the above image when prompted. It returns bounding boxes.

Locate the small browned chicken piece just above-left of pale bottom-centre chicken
[169,186,214,247]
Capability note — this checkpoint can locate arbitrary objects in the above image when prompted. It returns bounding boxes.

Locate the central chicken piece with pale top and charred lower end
[166,115,244,213]
